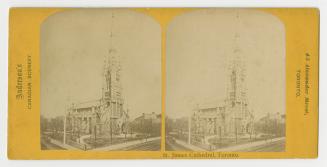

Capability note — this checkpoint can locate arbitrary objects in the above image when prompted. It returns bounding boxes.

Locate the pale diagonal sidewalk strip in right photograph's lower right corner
[214,137,285,152]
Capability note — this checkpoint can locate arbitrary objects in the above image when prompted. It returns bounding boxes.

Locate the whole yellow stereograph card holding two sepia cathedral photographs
[8,8,319,159]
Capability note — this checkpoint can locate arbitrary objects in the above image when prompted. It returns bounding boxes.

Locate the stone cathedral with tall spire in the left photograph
[65,13,129,140]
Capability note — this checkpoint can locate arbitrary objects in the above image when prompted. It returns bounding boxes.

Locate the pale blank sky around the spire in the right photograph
[166,9,285,119]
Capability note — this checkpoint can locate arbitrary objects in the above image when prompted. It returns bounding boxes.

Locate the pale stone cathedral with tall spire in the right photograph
[191,34,254,140]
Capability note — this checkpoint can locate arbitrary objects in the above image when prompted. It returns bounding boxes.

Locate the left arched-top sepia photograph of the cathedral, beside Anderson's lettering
[40,9,161,151]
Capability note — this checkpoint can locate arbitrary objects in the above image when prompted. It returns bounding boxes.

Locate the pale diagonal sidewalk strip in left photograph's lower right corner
[90,137,161,151]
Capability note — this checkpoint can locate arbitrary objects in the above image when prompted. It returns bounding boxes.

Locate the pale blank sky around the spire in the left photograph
[41,9,161,118]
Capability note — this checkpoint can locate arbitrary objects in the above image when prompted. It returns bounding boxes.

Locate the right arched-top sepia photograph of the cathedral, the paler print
[165,9,286,152]
